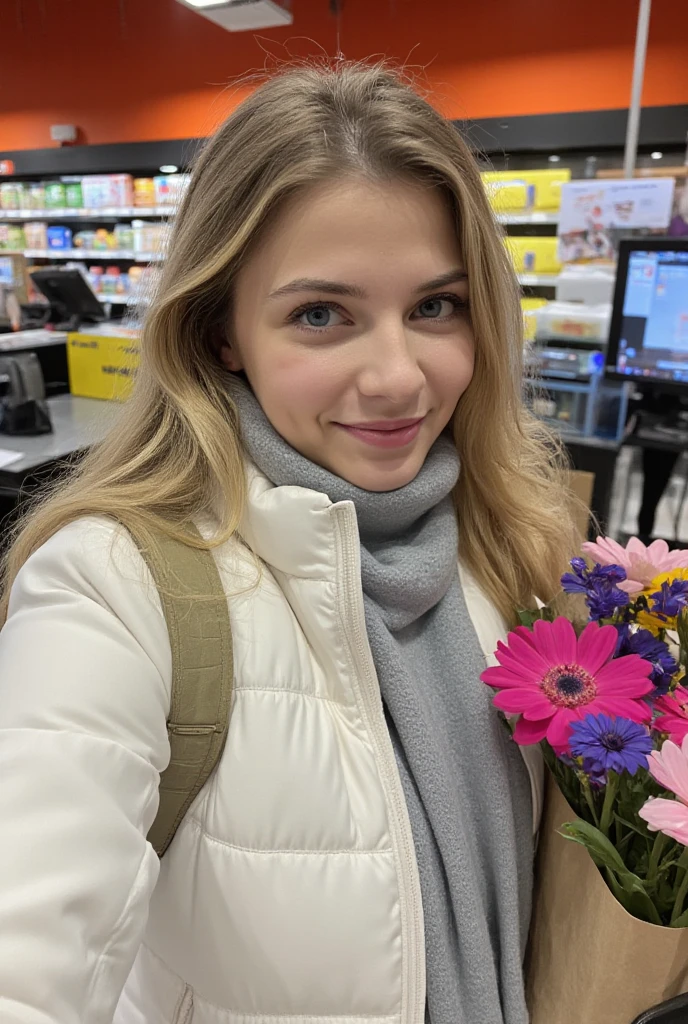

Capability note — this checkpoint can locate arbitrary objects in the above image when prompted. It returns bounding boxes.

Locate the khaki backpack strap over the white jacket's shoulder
[132,527,233,857]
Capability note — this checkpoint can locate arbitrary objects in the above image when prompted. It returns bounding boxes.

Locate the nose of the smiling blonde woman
[358,322,425,403]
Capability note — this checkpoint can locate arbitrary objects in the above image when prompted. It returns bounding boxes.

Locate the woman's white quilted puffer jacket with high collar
[0,472,541,1024]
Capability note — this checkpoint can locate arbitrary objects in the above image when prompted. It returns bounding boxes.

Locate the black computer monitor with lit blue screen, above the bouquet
[606,239,688,391]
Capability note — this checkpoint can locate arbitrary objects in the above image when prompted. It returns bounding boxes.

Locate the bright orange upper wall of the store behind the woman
[0,0,688,151]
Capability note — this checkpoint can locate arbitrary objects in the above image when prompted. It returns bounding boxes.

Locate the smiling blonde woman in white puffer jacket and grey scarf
[0,65,573,1024]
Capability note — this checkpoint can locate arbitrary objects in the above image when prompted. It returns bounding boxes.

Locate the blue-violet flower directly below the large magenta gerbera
[569,715,652,777]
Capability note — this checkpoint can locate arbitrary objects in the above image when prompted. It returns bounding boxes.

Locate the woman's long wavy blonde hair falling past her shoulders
[0,61,575,621]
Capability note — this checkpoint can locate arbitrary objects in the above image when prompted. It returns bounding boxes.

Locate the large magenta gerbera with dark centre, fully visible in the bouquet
[480,617,652,753]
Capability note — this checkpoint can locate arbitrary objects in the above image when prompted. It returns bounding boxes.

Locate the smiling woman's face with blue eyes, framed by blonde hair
[222,179,474,490]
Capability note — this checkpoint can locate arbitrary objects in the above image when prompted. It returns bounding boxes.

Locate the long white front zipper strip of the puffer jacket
[332,502,426,1024]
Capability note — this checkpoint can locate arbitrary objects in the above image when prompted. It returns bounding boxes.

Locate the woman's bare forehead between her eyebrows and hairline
[238,179,461,291]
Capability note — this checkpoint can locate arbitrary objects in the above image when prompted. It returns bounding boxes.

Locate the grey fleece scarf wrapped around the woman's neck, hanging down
[230,379,533,1024]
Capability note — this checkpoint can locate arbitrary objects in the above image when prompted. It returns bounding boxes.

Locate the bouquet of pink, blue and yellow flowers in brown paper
[482,538,688,1024]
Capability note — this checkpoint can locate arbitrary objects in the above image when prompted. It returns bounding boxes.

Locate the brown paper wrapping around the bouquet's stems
[526,778,688,1024]
